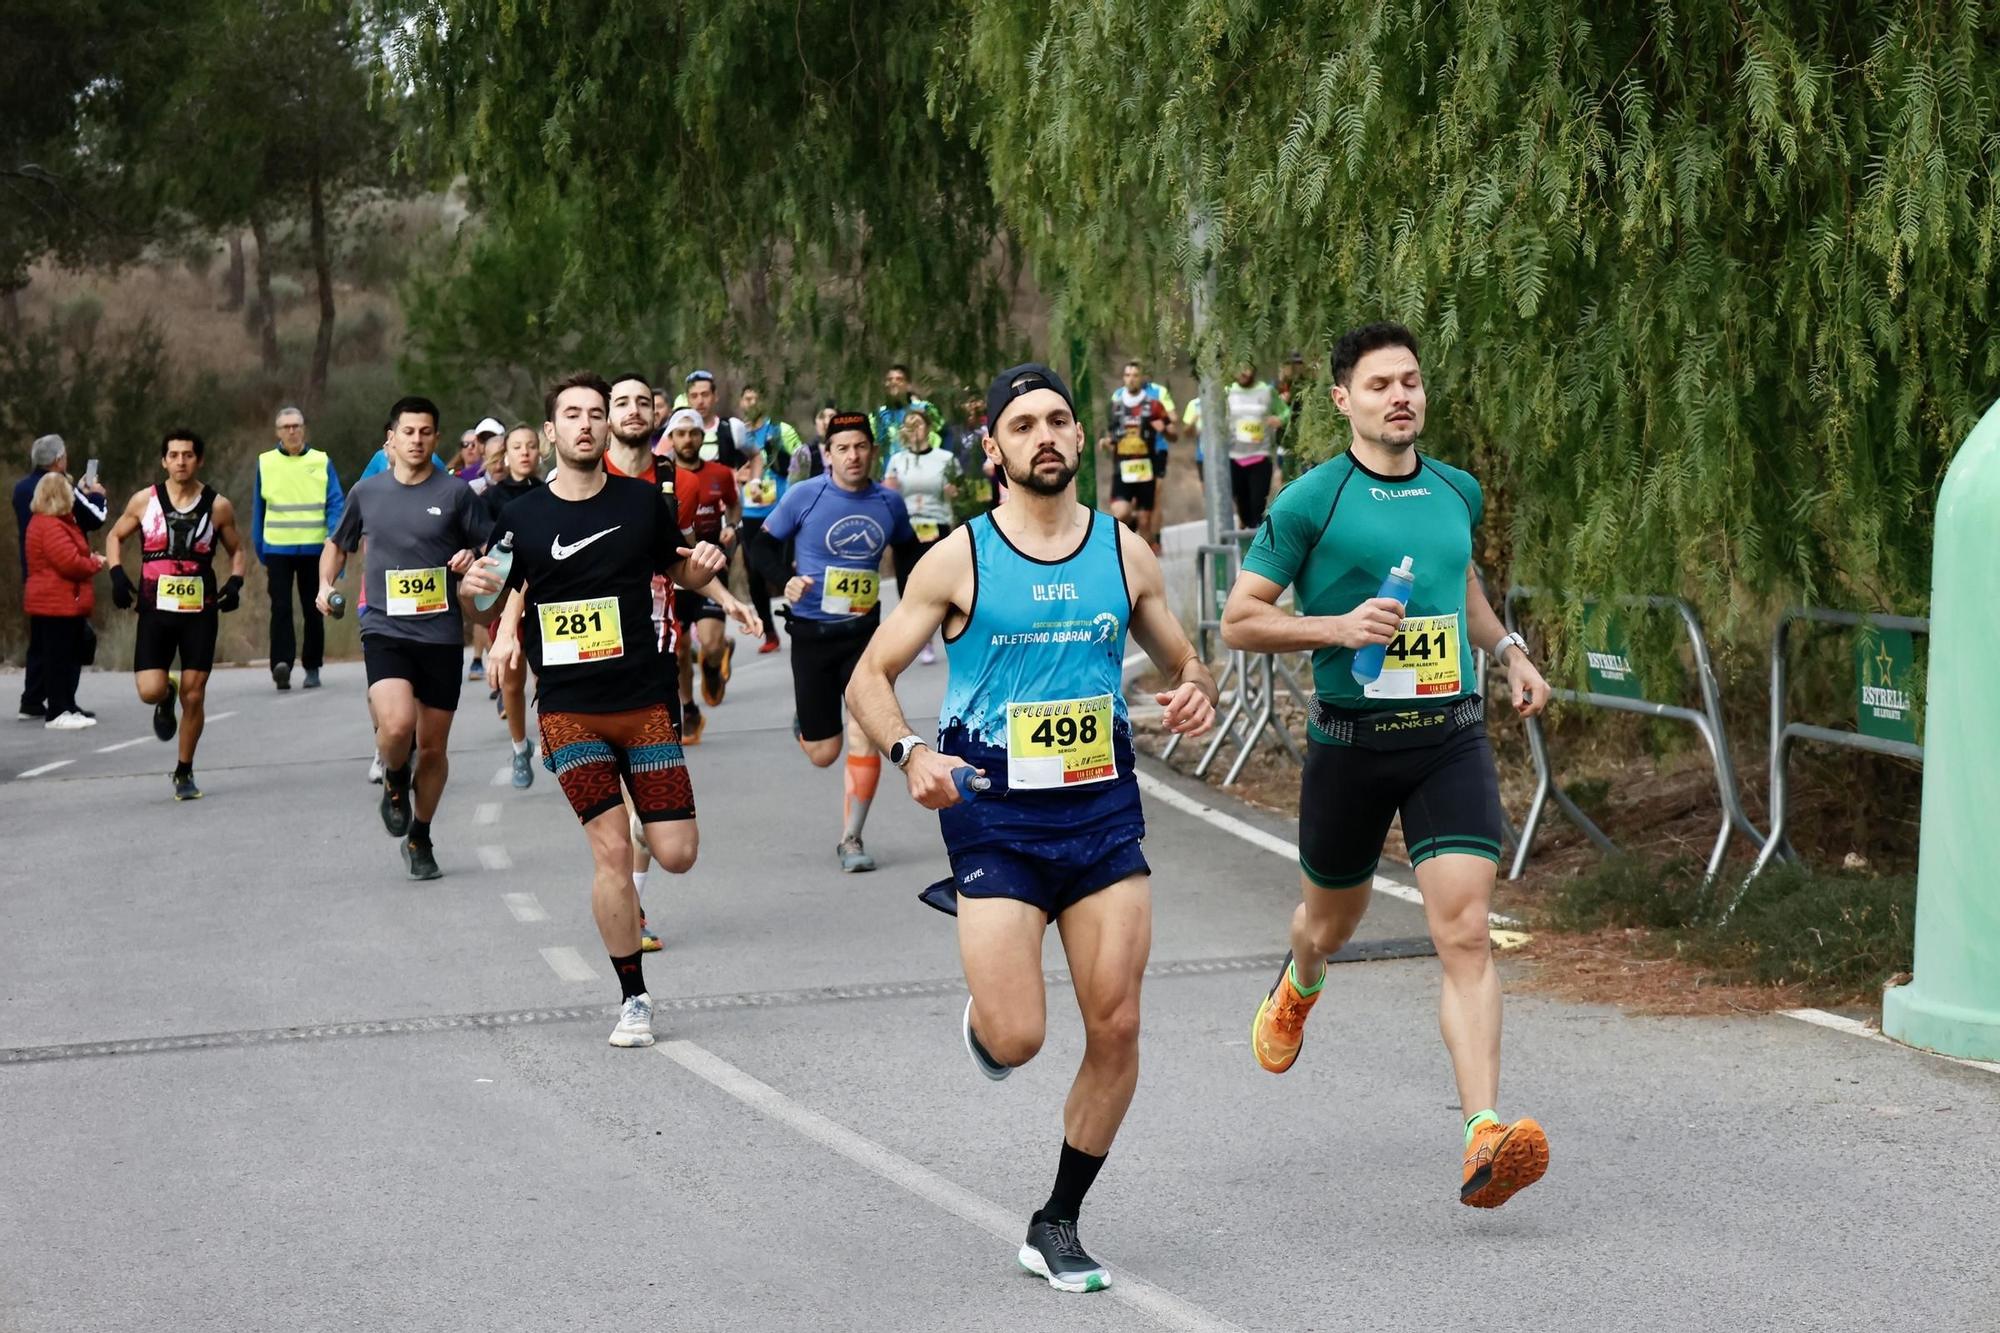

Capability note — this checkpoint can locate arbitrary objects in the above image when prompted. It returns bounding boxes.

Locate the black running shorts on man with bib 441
[1298,723,1500,889]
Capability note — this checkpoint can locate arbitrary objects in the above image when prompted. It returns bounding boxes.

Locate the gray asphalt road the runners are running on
[0,656,2000,1333]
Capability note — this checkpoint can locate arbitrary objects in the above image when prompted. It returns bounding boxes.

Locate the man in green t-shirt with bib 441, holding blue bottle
[1222,324,1548,1209]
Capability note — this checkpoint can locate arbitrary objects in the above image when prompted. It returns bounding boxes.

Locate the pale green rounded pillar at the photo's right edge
[1882,406,2000,1061]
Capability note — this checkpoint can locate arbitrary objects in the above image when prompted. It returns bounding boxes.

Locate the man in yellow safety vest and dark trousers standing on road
[250,406,346,691]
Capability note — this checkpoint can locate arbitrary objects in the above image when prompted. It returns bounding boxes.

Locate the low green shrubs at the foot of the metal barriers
[1538,857,1916,1003]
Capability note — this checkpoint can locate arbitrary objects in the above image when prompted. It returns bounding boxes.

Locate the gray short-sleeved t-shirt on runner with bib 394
[332,468,488,644]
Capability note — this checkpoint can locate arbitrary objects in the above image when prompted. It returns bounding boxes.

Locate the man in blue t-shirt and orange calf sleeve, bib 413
[750,412,916,875]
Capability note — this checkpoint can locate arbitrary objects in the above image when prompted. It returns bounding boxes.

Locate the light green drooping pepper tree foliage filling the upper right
[942,0,2000,634]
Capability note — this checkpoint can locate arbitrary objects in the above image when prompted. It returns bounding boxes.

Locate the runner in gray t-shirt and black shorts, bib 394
[320,398,486,879]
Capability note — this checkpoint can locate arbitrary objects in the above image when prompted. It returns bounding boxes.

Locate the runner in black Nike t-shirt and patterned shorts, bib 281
[460,374,728,1047]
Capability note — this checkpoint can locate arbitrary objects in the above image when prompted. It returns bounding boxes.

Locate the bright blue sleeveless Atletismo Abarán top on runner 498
[938,512,1146,851]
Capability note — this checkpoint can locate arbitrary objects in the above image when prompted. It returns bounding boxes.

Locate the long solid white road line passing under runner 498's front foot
[654,1041,1242,1333]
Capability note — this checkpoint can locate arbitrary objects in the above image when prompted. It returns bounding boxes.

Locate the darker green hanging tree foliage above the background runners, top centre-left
[400,0,1002,404]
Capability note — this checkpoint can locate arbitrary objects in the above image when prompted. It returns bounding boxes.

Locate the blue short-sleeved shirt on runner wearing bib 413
[764,472,916,622]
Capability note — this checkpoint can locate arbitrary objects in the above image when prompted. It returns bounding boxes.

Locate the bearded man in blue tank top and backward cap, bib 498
[848,364,1216,1291]
